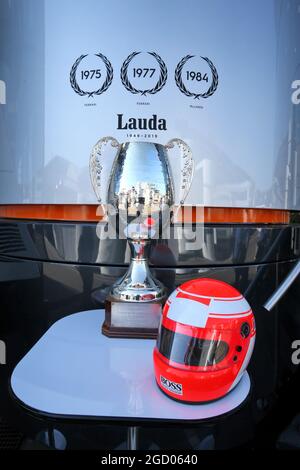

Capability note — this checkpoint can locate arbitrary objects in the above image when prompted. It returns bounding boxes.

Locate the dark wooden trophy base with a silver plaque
[102,296,163,339]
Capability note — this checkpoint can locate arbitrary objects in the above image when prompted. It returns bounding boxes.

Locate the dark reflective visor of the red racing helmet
[157,325,229,367]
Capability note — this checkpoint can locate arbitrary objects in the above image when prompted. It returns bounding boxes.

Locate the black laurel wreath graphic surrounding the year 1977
[120,52,168,96]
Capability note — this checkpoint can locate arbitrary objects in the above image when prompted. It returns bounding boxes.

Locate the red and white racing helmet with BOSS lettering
[153,278,256,403]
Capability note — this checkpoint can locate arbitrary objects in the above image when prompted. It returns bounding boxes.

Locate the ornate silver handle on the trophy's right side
[165,139,195,207]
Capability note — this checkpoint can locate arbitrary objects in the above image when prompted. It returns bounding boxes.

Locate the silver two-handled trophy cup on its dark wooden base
[90,137,194,338]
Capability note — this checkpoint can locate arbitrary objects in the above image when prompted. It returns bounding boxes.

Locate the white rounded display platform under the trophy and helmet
[11,310,250,421]
